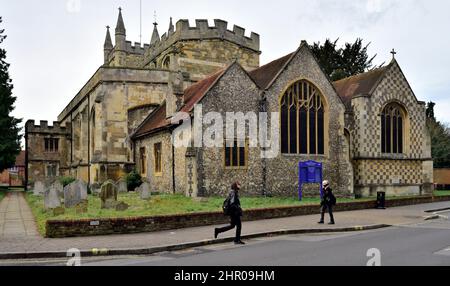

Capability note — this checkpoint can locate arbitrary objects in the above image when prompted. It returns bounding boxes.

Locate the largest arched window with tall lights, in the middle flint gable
[280,80,325,154]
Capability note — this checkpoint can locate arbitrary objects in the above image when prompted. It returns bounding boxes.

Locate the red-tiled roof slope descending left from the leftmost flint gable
[133,69,227,138]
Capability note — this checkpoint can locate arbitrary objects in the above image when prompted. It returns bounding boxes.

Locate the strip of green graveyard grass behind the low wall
[26,192,373,236]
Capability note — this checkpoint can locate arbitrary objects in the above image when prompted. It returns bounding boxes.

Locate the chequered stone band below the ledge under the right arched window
[355,160,423,186]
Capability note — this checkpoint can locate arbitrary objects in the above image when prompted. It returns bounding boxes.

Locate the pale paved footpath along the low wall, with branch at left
[0,193,450,254]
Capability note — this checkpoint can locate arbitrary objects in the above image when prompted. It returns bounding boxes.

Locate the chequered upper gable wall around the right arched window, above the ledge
[352,63,426,159]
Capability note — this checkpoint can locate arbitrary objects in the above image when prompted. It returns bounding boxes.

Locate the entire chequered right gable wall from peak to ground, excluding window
[352,61,433,196]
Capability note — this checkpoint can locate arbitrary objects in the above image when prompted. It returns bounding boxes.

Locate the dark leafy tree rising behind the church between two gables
[311,38,376,81]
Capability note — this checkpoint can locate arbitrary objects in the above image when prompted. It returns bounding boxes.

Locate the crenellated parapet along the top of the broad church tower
[145,19,260,65]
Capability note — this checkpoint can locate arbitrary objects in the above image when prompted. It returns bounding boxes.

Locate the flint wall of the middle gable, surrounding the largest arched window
[265,44,353,197]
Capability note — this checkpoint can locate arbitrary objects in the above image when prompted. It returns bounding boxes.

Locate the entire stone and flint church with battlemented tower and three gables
[25,8,433,197]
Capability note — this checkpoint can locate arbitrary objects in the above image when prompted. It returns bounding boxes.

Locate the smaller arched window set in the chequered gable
[381,103,405,154]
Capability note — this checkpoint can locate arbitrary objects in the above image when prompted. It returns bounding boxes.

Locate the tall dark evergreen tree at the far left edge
[0,17,22,172]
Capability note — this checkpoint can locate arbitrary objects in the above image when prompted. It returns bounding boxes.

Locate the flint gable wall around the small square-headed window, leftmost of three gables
[197,64,263,196]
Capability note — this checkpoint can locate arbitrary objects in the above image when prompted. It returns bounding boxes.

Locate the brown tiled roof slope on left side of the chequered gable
[333,65,390,110]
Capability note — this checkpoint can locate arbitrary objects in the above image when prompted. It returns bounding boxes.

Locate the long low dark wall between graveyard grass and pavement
[46,196,450,238]
